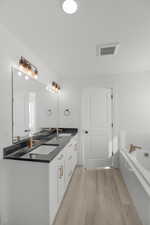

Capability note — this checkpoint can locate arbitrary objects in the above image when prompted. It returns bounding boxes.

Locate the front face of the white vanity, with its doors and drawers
[49,136,78,224]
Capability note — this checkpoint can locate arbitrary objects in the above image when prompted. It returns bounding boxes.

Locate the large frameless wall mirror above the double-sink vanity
[12,68,59,143]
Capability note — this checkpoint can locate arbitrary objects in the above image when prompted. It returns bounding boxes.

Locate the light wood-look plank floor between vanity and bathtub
[54,168,142,225]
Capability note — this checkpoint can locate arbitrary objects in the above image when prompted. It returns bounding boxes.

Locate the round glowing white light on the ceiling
[62,0,78,14]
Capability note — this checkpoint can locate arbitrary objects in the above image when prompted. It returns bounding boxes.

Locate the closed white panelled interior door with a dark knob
[82,88,112,168]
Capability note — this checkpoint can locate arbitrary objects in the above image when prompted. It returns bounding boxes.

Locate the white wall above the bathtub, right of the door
[117,72,150,149]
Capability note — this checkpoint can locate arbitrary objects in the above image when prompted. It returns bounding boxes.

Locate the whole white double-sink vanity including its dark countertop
[4,129,78,225]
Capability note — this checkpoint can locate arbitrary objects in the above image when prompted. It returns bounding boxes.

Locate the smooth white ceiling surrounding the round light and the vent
[0,0,150,78]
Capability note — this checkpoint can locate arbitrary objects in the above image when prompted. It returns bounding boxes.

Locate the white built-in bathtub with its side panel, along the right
[120,149,150,225]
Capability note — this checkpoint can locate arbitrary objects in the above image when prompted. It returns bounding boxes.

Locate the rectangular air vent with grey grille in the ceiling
[96,43,119,56]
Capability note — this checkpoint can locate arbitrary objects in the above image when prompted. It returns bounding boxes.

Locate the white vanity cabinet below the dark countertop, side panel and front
[3,134,77,225]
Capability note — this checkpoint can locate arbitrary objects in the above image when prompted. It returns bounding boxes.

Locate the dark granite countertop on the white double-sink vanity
[3,128,78,163]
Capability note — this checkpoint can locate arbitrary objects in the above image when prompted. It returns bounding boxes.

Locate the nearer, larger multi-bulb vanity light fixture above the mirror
[18,56,38,80]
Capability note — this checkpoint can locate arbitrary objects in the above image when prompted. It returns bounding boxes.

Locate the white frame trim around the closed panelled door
[81,86,114,168]
